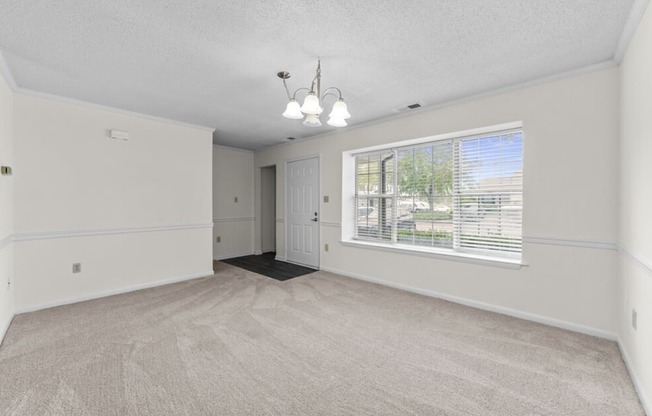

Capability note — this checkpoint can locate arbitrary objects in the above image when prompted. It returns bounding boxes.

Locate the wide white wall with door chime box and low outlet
[14,93,212,312]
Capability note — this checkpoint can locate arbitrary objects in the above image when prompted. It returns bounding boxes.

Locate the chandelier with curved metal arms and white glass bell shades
[276,60,351,127]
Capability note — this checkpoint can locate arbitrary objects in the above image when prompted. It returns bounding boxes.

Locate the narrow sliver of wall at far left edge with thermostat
[0,66,15,344]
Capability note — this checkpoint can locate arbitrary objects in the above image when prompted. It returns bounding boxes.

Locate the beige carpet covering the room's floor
[0,263,644,416]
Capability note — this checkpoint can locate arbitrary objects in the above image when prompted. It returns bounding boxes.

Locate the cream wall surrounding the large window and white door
[255,68,619,337]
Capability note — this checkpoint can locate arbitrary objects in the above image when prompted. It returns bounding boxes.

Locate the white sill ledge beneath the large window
[340,240,527,270]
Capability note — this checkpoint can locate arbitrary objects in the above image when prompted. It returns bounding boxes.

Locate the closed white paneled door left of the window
[285,157,319,268]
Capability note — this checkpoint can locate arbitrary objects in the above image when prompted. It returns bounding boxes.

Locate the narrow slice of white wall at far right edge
[618,1,652,414]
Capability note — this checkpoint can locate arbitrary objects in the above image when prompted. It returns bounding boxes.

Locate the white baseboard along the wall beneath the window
[321,267,618,341]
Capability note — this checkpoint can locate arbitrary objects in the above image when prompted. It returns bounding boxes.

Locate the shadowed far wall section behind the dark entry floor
[212,146,254,260]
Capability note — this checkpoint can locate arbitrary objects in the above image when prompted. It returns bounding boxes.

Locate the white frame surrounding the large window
[341,121,525,268]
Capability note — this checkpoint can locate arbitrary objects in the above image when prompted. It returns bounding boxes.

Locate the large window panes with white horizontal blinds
[354,130,523,259]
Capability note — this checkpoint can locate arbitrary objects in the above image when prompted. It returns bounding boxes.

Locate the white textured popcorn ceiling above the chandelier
[0,0,634,149]
